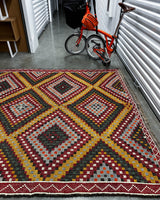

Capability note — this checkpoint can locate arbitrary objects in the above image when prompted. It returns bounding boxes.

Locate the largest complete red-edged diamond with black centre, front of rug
[18,110,91,178]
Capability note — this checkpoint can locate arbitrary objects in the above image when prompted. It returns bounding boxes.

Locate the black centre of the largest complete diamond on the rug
[38,125,69,152]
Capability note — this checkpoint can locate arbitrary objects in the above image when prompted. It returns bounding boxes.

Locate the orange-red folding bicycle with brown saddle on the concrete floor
[65,0,135,66]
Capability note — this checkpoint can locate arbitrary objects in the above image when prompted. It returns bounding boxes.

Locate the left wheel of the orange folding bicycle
[65,33,86,55]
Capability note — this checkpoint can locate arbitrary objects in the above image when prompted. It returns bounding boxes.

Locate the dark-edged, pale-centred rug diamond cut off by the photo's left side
[0,90,50,134]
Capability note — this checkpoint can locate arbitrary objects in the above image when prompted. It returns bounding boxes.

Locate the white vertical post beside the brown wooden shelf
[21,0,39,53]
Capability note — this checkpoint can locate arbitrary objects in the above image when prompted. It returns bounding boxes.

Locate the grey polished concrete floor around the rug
[0,10,160,200]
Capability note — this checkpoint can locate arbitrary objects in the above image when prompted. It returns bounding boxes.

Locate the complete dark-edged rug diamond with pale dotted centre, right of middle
[68,89,124,134]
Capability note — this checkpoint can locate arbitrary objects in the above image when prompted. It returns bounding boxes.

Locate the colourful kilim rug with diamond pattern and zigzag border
[0,70,160,195]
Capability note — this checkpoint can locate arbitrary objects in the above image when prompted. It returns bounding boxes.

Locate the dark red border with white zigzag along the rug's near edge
[0,182,160,196]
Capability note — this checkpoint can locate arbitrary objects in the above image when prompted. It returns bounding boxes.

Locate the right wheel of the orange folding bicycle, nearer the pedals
[86,35,105,60]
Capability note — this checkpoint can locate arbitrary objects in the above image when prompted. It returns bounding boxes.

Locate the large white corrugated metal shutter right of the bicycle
[117,0,160,119]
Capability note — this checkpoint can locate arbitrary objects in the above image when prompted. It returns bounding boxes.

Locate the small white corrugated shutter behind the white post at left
[32,0,49,37]
